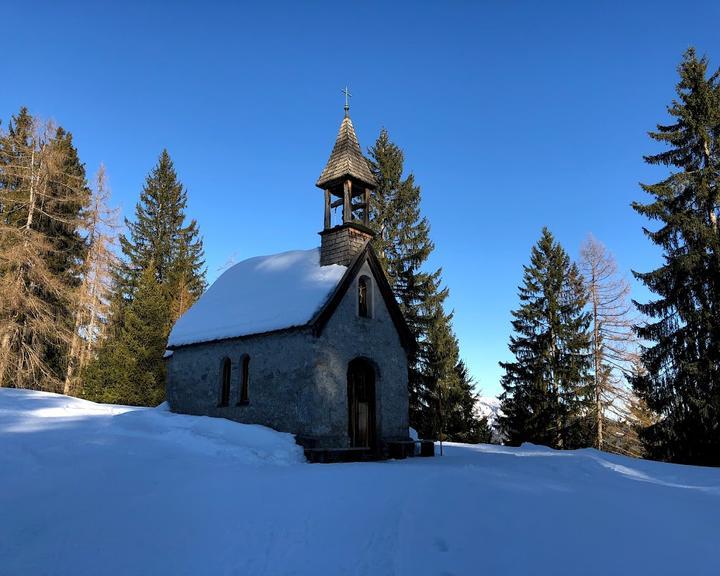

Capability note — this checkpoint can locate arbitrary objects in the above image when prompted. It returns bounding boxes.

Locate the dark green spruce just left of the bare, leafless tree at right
[500,228,594,448]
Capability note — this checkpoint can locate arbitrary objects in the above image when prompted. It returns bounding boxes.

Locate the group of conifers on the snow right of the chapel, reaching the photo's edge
[500,49,720,466]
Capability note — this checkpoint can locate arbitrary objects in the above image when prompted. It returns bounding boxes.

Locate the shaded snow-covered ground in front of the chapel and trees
[0,389,720,576]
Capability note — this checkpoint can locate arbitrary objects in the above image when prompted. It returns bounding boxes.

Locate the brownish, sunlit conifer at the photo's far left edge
[0,108,88,391]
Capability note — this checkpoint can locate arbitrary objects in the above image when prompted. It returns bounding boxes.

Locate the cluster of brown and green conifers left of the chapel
[0,108,205,405]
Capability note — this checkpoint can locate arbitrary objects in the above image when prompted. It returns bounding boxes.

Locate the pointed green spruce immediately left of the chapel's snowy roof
[84,150,205,404]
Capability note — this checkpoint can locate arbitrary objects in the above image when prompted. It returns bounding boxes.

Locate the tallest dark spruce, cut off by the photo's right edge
[633,49,720,465]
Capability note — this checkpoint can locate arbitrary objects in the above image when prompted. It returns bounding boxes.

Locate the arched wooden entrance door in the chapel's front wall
[348,358,375,448]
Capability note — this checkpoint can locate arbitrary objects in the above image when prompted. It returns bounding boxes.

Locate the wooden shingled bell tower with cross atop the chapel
[315,88,376,266]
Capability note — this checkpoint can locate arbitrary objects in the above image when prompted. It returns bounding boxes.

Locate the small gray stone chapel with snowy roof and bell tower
[167,104,414,453]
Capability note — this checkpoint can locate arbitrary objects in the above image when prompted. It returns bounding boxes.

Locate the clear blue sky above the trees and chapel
[0,0,720,394]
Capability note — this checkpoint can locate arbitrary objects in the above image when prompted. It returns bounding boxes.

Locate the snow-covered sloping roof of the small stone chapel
[168,248,347,346]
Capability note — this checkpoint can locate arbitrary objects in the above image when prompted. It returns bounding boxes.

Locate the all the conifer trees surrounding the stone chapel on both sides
[0,49,720,465]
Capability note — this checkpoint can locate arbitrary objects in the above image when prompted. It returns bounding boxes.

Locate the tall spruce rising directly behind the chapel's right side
[368,129,480,438]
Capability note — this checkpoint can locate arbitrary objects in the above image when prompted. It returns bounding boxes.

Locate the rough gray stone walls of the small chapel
[167,262,408,448]
